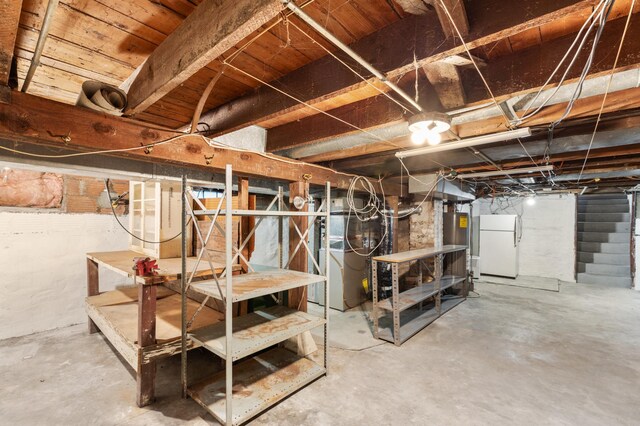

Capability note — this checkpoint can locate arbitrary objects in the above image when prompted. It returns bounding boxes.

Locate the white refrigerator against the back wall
[480,214,519,278]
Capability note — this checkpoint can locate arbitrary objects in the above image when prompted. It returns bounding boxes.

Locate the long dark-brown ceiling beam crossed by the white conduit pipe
[201,0,597,135]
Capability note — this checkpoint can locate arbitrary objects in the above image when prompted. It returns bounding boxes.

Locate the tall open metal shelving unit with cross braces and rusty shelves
[182,165,331,425]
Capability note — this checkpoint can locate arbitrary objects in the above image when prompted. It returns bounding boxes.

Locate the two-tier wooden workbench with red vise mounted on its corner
[85,250,241,407]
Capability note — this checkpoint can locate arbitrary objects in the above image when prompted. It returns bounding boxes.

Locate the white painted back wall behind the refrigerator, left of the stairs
[473,194,576,282]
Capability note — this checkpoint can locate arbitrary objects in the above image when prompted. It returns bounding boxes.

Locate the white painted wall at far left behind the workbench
[0,211,128,339]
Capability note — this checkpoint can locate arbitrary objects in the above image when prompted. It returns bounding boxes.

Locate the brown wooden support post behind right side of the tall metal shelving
[289,181,309,312]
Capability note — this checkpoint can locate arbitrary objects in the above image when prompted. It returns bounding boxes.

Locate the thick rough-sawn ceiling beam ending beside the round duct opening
[126,0,283,115]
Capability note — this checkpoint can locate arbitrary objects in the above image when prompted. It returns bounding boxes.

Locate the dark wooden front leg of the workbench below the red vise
[136,284,157,407]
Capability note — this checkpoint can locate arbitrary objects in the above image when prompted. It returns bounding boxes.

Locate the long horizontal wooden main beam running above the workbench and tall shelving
[0,92,401,194]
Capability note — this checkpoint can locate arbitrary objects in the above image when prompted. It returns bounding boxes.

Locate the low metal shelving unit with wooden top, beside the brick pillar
[371,245,467,346]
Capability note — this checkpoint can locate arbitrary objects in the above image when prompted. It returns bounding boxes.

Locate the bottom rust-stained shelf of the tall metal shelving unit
[189,348,326,425]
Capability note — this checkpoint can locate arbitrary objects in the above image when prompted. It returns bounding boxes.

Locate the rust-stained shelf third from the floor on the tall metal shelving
[191,269,326,302]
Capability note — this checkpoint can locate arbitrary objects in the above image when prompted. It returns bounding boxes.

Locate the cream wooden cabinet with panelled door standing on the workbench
[129,180,191,259]
